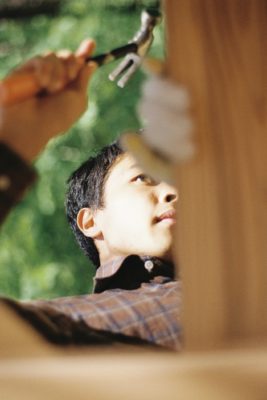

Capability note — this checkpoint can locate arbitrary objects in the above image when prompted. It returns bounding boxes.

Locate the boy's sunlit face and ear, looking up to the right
[95,153,178,257]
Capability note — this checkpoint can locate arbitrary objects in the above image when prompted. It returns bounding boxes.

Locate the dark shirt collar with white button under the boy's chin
[94,255,175,293]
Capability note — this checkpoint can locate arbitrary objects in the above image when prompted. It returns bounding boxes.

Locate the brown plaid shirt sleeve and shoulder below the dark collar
[0,281,182,351]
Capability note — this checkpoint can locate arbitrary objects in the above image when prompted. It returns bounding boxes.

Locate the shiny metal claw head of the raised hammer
[109,9,161,88]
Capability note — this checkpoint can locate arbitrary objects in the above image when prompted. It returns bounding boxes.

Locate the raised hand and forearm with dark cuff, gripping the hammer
[0,39,96,223]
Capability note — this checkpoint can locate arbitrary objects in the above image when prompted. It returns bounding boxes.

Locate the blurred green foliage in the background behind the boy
[0,0,164,299]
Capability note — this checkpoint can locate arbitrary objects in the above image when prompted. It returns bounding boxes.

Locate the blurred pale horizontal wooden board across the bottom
[0,347,267,400]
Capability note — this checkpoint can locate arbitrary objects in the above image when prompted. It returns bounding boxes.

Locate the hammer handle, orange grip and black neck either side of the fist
[0,42,138,106]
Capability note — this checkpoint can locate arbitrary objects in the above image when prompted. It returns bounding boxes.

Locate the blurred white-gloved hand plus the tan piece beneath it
[120,76,195,184]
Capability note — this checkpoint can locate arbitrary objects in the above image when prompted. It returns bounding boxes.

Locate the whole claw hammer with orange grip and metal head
[0,9,161,106]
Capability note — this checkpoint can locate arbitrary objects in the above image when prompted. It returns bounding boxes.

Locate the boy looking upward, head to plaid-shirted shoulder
[16,143,181,350]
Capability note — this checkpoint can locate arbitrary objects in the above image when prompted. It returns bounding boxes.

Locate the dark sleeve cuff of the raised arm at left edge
[0,142,37,224]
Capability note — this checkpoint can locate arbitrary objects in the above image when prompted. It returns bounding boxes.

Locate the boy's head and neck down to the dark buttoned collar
[66,143,178,292]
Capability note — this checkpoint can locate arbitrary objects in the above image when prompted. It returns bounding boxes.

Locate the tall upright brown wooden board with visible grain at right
[164,0,267,348]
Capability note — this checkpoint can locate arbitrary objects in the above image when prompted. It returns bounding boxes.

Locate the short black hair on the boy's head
[65,142,123,268]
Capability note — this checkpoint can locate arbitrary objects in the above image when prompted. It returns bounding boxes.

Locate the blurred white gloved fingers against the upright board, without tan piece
[138,76,195,162]
